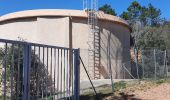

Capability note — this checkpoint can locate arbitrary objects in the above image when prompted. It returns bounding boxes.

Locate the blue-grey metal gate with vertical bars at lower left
[0,39,80,100]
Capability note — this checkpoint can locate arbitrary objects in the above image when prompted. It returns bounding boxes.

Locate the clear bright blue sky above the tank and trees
[0,0,170,20]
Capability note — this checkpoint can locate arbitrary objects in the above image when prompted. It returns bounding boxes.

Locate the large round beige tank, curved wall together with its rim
[0,10,130,80]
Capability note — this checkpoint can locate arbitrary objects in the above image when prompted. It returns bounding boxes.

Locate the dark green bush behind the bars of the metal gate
[0,45,50,100]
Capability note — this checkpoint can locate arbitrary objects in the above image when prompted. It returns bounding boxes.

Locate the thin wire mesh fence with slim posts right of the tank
[122,49,170,79]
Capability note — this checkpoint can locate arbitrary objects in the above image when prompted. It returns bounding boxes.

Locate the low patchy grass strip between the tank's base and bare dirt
[80,77,170,100]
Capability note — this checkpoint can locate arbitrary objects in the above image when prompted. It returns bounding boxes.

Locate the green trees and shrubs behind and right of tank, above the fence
[99,1,170,53]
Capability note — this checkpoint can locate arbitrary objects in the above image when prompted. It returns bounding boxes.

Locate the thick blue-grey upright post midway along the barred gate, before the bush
[22,43,31,100]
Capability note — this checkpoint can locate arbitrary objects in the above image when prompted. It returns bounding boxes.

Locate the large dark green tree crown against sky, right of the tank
[120,1,163,26]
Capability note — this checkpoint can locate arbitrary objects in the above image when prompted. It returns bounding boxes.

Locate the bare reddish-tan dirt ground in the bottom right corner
[105,82,170,100]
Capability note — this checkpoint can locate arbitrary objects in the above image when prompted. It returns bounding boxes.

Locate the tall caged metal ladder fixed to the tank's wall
[83,0,101,79]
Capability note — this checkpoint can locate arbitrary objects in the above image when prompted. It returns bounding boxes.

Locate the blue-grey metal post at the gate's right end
[74,49,80,100]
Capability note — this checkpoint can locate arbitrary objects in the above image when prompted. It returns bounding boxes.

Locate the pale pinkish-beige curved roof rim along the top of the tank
[0,9,131,30]
